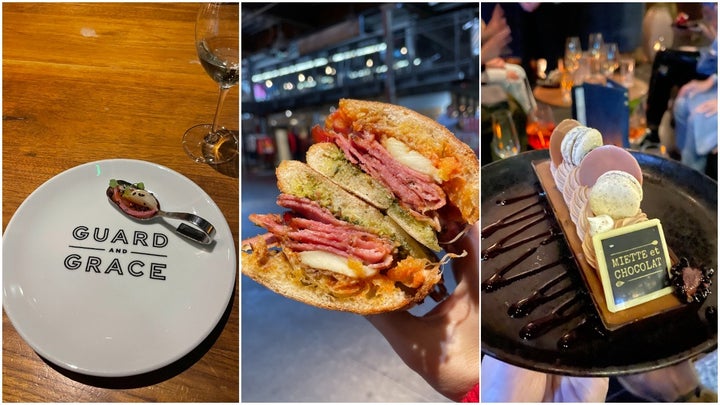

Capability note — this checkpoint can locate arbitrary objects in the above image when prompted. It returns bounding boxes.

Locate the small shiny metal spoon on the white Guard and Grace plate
[105,180,215,245]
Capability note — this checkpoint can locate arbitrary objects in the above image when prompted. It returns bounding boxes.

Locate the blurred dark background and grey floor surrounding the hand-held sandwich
[241,2,480,402]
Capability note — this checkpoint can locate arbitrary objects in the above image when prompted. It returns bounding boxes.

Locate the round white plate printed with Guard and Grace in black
[3,159,237,377]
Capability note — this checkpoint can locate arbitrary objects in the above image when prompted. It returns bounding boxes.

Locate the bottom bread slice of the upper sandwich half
[305,142,441,252]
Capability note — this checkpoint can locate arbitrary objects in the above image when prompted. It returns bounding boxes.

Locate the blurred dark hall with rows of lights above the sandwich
[241,3,479,170]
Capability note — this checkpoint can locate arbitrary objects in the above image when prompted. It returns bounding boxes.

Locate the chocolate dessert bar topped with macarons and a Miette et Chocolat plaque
[536,123,709,318]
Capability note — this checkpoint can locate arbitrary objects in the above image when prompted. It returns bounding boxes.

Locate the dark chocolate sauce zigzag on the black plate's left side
[480,188,602,349]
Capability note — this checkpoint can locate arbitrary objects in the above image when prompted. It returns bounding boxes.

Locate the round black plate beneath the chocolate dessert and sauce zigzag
[481,150,717,376]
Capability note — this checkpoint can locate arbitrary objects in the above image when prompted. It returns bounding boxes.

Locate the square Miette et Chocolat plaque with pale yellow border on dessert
[593,219,672,312]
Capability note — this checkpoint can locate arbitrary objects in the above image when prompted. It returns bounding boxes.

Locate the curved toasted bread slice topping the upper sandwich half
[325,99,480,224]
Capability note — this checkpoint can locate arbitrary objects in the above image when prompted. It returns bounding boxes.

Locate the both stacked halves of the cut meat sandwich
[242,100,479,315]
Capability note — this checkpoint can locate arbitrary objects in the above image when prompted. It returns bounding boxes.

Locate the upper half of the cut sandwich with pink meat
[307,99,480,252]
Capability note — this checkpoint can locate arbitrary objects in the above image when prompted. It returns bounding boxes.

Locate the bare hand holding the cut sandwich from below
[367,224,480,401]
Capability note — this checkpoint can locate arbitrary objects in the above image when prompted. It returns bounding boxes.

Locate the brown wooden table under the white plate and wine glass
[2,3,239,402]
